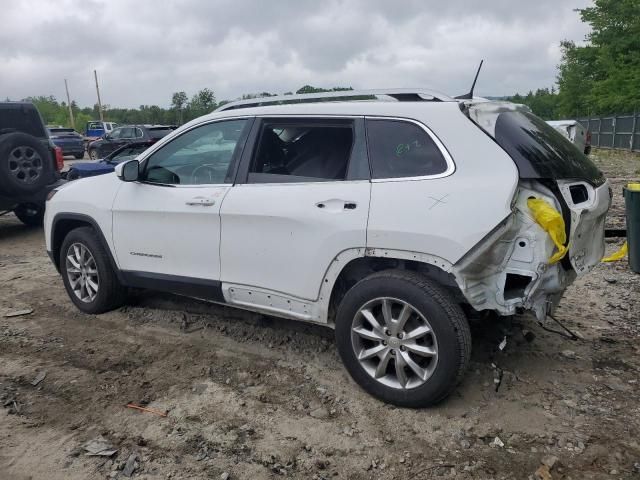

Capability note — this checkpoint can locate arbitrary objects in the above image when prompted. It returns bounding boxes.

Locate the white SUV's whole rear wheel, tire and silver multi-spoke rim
[336,270,471,408]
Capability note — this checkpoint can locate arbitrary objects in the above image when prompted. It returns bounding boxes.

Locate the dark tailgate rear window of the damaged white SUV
[495,112,605,186]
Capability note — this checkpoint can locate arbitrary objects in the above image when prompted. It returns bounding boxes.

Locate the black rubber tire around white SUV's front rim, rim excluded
[60,227,127,314]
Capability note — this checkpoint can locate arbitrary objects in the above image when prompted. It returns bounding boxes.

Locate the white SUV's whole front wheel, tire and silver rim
[60,227,126,314]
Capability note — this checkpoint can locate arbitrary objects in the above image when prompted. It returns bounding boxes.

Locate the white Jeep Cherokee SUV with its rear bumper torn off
[45,90,610,407]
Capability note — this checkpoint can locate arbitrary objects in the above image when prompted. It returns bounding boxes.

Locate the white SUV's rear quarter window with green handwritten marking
[367,119,447,178]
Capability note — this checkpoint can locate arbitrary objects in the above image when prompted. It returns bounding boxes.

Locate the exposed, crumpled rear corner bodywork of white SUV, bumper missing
[452,180,611,321]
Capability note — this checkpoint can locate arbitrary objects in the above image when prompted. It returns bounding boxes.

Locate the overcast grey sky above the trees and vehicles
[0,0,590,107]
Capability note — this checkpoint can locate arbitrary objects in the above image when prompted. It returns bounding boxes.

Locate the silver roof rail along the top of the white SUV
[215,88,455,112]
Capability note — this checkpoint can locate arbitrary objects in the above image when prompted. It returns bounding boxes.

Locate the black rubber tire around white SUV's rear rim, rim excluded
[335,270,471,408]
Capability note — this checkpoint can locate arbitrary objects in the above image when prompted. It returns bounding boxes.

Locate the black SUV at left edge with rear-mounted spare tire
[0,102,64,225]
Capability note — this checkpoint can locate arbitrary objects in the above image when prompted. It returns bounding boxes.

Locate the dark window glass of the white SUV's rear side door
[249,119,354,183]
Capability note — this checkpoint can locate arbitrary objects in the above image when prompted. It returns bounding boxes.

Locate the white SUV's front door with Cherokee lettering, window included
[113,119,251,284]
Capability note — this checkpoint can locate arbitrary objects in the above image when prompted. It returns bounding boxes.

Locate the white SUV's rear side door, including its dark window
[220,117,371,300]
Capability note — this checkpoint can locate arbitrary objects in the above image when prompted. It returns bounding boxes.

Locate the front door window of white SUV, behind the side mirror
[143,119,249,185]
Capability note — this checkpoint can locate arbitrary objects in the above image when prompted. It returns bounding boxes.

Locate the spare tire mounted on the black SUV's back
[0,132,53,195]
